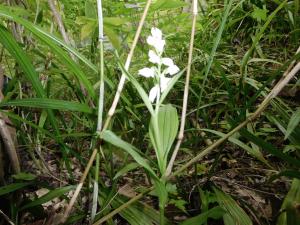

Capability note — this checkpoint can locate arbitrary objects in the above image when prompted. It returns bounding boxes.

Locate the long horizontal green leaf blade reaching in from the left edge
[0,98,93,114]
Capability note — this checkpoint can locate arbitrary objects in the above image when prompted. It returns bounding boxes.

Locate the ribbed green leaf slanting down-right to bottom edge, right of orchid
[213,188,253,225]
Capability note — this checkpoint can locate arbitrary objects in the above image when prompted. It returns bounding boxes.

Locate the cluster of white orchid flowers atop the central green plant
[139,27,179,102]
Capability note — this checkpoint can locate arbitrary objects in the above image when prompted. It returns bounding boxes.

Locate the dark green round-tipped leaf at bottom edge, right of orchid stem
[180,206,225,225]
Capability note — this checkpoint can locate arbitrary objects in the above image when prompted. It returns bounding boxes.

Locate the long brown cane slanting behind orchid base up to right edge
[93,55,300,225]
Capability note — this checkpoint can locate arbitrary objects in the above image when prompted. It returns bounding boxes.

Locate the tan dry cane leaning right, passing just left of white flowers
[60,0,151,223]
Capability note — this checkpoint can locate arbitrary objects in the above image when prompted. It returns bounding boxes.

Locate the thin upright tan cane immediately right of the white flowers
[165,0,198,176]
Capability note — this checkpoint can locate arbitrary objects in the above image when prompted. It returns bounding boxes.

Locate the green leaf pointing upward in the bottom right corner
[277,179,300,225]
